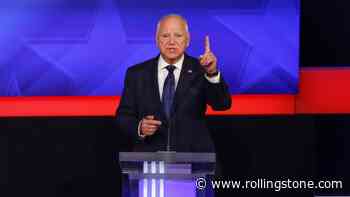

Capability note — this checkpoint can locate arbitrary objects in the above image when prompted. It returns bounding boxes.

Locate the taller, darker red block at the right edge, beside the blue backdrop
[296,68,350,114]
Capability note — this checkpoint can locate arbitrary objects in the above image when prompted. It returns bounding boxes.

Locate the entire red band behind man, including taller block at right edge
[0,68,350,117]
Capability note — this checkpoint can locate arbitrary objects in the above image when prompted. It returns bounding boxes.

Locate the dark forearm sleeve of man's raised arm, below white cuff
[205,75,232,111]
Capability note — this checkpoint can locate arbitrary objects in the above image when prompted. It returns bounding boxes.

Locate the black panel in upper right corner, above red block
[300,0,350,67]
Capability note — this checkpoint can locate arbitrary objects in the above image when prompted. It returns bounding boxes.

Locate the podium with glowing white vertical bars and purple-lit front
[119,152,216,197]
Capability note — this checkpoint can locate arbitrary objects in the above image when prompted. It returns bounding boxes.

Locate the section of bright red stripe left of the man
[0,96,119,117]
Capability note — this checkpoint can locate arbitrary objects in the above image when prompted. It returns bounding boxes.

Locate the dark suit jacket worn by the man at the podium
[117,55,231,152]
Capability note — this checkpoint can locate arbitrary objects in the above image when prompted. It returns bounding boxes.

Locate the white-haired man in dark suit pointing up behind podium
[117,15,231,152]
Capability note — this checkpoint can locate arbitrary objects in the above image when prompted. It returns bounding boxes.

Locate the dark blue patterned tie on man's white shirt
[162,65,176,119]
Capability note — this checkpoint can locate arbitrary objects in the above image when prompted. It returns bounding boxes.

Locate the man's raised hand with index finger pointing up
[199,36,218,76]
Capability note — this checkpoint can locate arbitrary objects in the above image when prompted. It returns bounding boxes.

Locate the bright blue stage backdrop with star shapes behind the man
[0,0,300,96]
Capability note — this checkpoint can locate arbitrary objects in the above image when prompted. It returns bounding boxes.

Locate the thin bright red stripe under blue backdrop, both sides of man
[0,95,294,117]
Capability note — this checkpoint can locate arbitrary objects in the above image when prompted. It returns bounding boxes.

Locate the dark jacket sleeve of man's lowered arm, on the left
[116,69,139,140]
